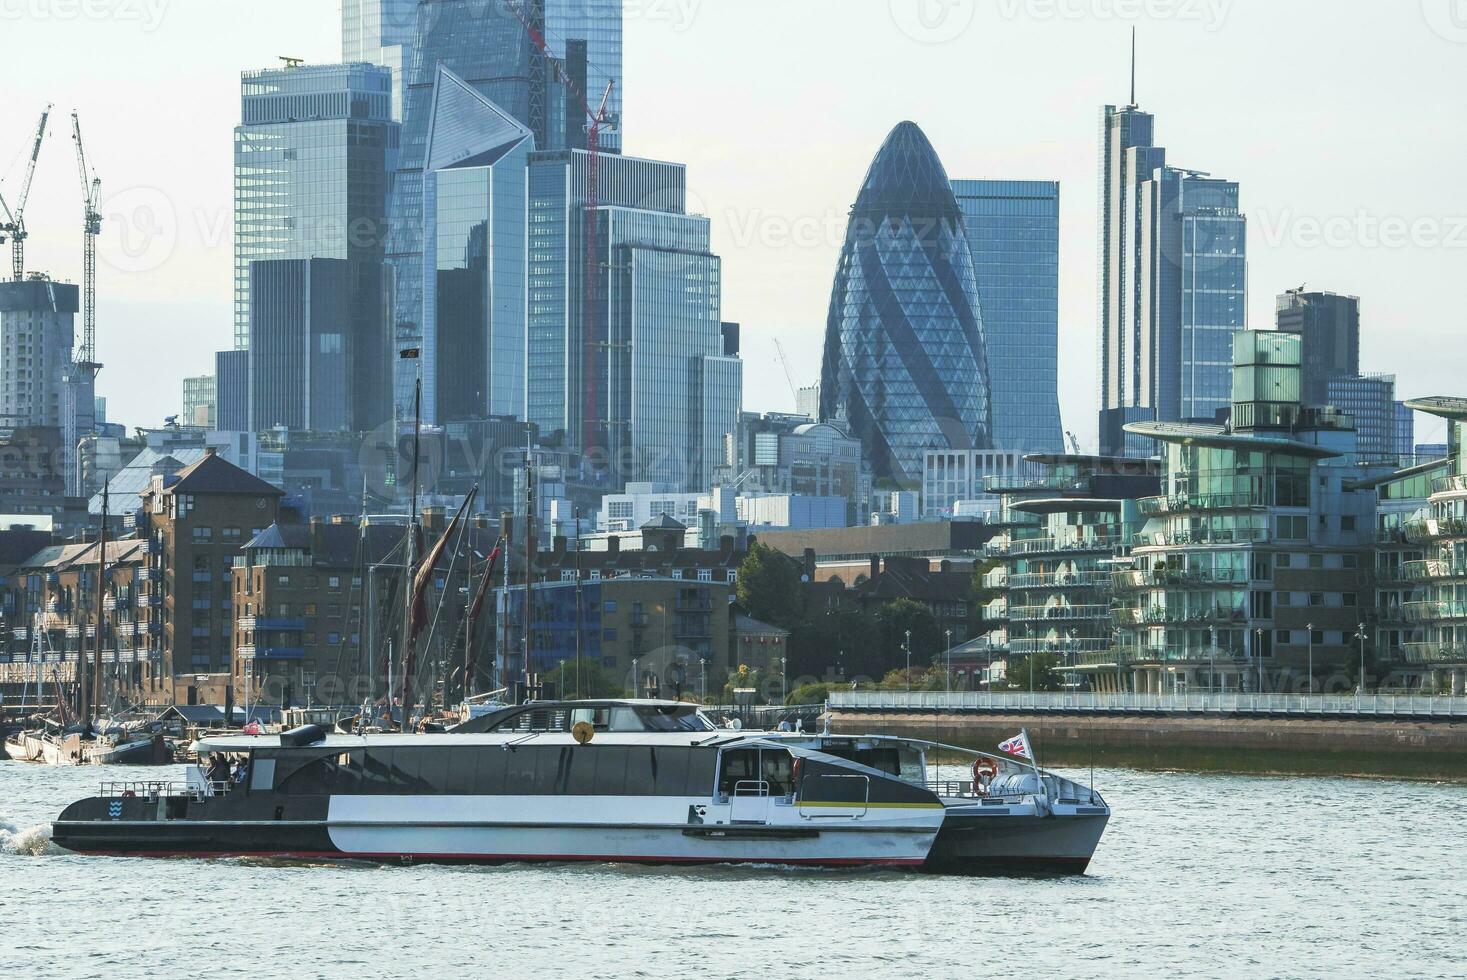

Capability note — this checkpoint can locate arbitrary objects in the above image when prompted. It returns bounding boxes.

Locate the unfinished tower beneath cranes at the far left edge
[0,279,79,430]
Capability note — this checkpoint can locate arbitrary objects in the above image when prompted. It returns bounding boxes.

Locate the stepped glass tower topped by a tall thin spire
[1099,106,1247,456]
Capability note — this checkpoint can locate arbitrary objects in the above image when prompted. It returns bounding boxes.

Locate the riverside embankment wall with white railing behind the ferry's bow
[827,691,1467,780]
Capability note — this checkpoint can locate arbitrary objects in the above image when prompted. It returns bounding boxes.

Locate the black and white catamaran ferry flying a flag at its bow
[53,700,1111,874]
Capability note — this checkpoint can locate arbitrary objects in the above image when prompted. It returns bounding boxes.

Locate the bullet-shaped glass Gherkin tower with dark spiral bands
[820,122,992,487]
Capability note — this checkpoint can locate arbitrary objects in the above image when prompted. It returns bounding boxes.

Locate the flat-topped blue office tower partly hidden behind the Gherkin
[952,180,1065,453]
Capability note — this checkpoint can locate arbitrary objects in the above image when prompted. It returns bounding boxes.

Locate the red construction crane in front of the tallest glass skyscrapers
[505,0,616,449]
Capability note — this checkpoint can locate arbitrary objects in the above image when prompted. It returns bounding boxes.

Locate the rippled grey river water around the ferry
[0,761,1467,980]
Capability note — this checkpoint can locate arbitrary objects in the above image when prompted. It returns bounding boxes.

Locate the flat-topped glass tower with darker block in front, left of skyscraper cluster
[235,65,398,431]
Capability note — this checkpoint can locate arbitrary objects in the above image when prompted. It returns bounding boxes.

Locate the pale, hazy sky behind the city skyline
[0,0,1467,449]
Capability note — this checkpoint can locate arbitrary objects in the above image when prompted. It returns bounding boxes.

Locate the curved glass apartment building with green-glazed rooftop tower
[1109,332,1376,694]
